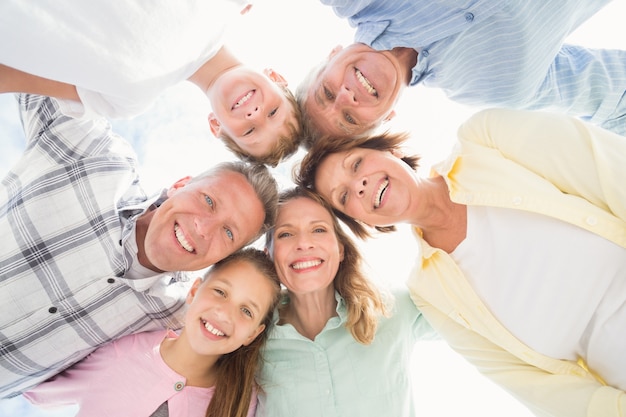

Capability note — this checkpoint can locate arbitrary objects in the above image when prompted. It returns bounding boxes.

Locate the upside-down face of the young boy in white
[207,66,296,157]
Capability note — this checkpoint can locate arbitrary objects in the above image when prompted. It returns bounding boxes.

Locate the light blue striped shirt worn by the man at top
[321,0,626,134]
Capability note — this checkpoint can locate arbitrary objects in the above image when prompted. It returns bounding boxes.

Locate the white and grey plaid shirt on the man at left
[0,95,187,398]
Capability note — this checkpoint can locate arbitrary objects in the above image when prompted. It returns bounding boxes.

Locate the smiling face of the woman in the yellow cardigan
[315,148,416,226]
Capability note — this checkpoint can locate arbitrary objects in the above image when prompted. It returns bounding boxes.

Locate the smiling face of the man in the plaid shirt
[144,171,265,271]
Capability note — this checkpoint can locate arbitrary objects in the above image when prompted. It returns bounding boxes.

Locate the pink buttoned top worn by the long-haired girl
[24,330,256,417]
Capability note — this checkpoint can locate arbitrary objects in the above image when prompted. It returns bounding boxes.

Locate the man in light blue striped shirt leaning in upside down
[297,0,626,144]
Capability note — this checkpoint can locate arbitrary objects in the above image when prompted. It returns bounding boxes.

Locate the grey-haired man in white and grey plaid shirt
[0,95,277,398]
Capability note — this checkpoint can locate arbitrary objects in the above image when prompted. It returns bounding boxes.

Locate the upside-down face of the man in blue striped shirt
[305,43,404,137]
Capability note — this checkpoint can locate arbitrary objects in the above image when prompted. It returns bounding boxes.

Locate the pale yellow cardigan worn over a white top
[408,109,626,417]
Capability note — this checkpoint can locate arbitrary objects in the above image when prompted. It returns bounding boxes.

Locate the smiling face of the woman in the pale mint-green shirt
[273,197,343,294]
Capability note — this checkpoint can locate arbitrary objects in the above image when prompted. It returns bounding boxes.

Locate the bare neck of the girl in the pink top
[160,329,222,388]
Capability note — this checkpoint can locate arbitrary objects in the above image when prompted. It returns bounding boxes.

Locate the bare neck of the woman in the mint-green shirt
[279,286,337,340]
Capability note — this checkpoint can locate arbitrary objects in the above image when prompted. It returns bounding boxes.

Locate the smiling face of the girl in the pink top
[185,261,274,355]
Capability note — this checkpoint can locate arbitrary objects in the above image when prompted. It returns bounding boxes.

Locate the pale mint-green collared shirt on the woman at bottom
[257,289,434,417]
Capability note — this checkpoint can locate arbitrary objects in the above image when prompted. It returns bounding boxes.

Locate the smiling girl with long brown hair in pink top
[24,248,280,417]
